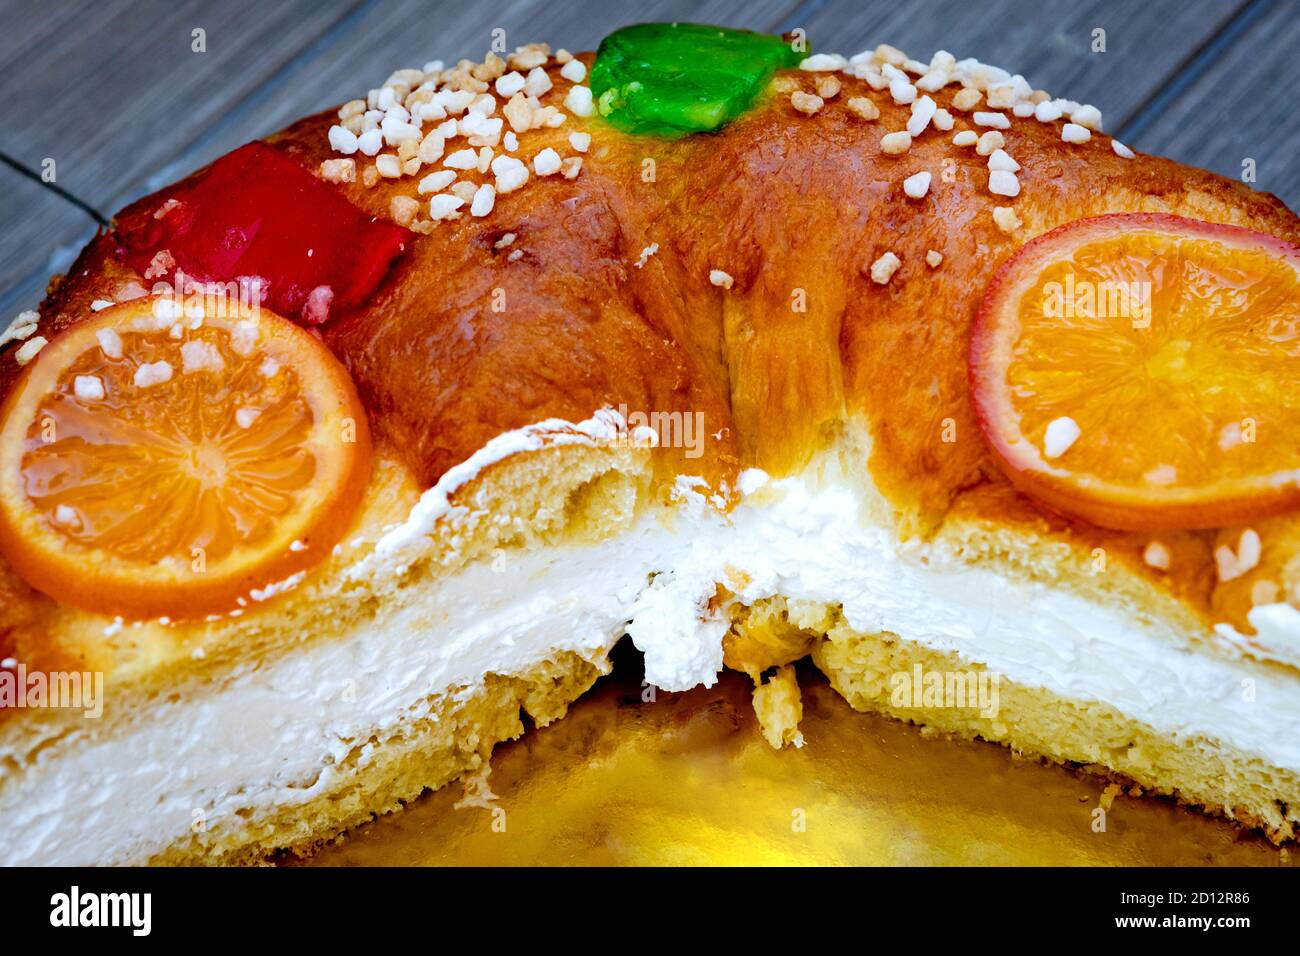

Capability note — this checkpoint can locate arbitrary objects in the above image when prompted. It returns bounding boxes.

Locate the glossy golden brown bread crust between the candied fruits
[0,55,1300,702]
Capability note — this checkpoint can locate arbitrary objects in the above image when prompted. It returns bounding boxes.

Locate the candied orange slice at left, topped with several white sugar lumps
[0,297,369,618]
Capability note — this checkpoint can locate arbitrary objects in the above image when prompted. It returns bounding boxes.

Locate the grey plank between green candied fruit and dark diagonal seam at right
[798,0,1242,129]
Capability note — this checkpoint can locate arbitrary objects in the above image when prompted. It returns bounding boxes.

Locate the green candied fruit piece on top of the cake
[590,23,807,137]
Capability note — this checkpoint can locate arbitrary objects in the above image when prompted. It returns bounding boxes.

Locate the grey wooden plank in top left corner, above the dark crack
[0,0,355,208]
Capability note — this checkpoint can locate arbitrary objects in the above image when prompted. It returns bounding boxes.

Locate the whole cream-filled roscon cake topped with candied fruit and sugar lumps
[0,23,1300,864]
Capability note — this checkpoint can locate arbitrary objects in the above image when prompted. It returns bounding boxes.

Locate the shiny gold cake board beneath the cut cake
[307,654,1300,866]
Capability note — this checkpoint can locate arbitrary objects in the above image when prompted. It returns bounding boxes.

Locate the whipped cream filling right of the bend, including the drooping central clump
[628,473,1300,769]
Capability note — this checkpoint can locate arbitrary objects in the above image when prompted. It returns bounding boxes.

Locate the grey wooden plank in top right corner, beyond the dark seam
[1132,0,1300,209]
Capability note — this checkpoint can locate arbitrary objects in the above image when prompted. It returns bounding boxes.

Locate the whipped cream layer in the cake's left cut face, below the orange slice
[0,525,663,865]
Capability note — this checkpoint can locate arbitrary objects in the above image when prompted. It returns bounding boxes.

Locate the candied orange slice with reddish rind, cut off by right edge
[970,213,1300,531]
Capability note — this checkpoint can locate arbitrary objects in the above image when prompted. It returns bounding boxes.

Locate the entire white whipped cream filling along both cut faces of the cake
[0,416,1300,864]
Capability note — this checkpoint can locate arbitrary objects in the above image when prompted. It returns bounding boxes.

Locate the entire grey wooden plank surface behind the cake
[0,0,1300,317]
